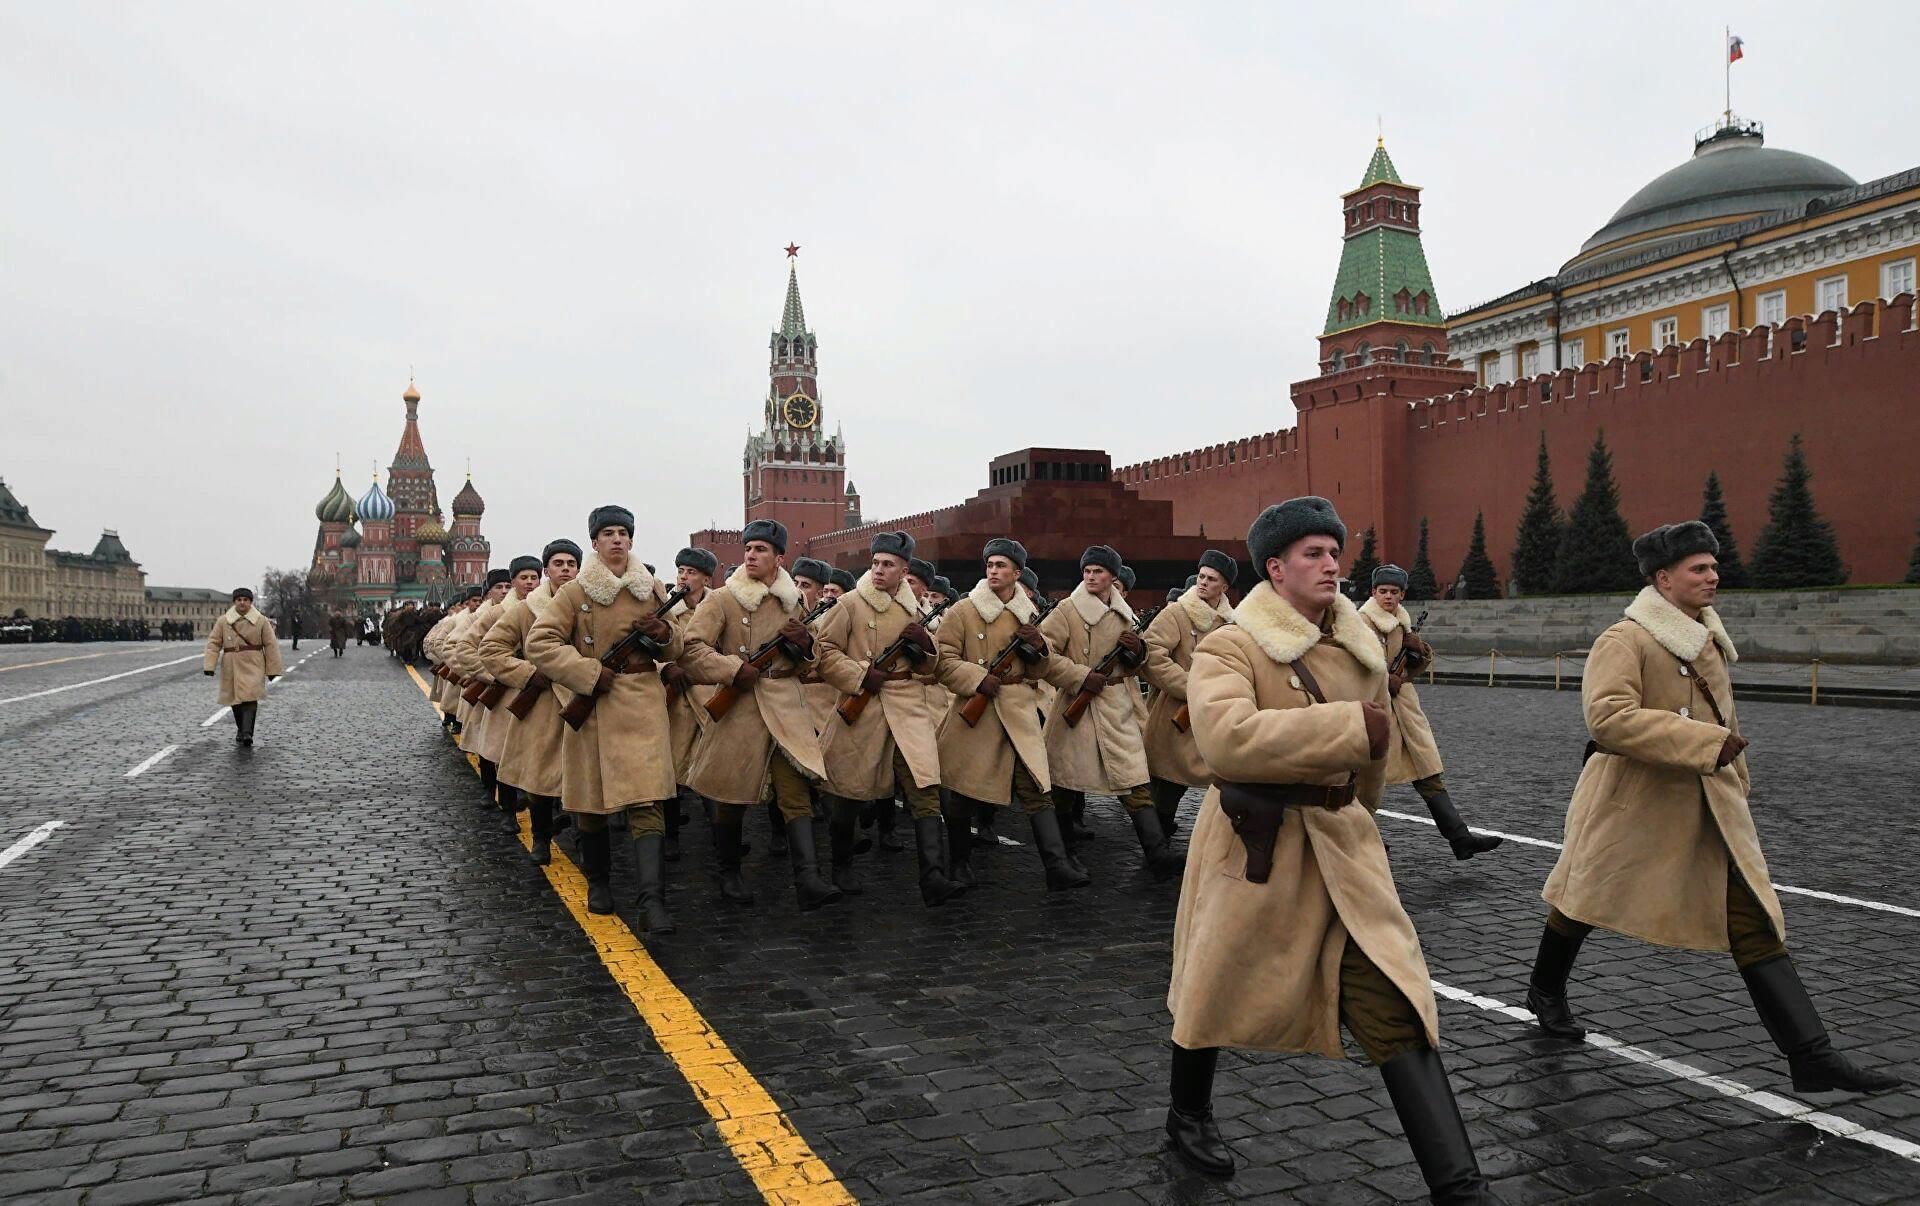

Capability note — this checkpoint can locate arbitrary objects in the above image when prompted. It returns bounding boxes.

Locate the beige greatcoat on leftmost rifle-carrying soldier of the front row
[526,553,682,812]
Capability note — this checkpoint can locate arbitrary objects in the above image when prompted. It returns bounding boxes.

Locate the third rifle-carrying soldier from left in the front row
[818,532,960,905]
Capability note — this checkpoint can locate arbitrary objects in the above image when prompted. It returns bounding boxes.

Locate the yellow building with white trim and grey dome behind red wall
[1448,117,1920,384]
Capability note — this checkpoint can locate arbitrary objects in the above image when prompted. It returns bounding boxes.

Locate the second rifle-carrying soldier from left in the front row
[680,519,841,910]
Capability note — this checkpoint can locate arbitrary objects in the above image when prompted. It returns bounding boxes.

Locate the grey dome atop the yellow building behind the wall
[1567,117,1857,269]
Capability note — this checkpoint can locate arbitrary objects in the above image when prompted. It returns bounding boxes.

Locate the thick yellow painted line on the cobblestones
[407,666,856,1206]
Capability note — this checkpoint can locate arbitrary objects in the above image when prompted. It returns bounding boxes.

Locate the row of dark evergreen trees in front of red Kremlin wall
[1350,432,1866,599]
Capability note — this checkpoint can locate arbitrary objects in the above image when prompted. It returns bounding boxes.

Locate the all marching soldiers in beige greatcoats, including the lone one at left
[180,489,1901,1202]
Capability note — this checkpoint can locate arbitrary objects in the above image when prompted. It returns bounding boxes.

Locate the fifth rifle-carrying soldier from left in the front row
[1041,543,1181,880]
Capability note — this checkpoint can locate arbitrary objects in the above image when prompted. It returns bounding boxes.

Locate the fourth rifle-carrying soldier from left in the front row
[933,536,1094,891]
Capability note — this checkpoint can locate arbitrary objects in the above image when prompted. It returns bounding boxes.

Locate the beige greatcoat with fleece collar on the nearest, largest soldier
[1167,582,1440,1058]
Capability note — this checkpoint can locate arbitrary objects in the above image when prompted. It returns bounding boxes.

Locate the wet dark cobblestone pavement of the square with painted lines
[0,641,1920,1206]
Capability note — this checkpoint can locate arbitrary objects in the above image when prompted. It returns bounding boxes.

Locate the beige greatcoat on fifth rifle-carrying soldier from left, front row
[1041,586,1148,795]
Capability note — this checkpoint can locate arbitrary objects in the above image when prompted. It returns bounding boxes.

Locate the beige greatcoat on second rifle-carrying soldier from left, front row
[680,567,828,805]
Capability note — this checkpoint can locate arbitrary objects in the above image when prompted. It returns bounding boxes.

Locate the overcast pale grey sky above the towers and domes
[0,0,1920,588]
